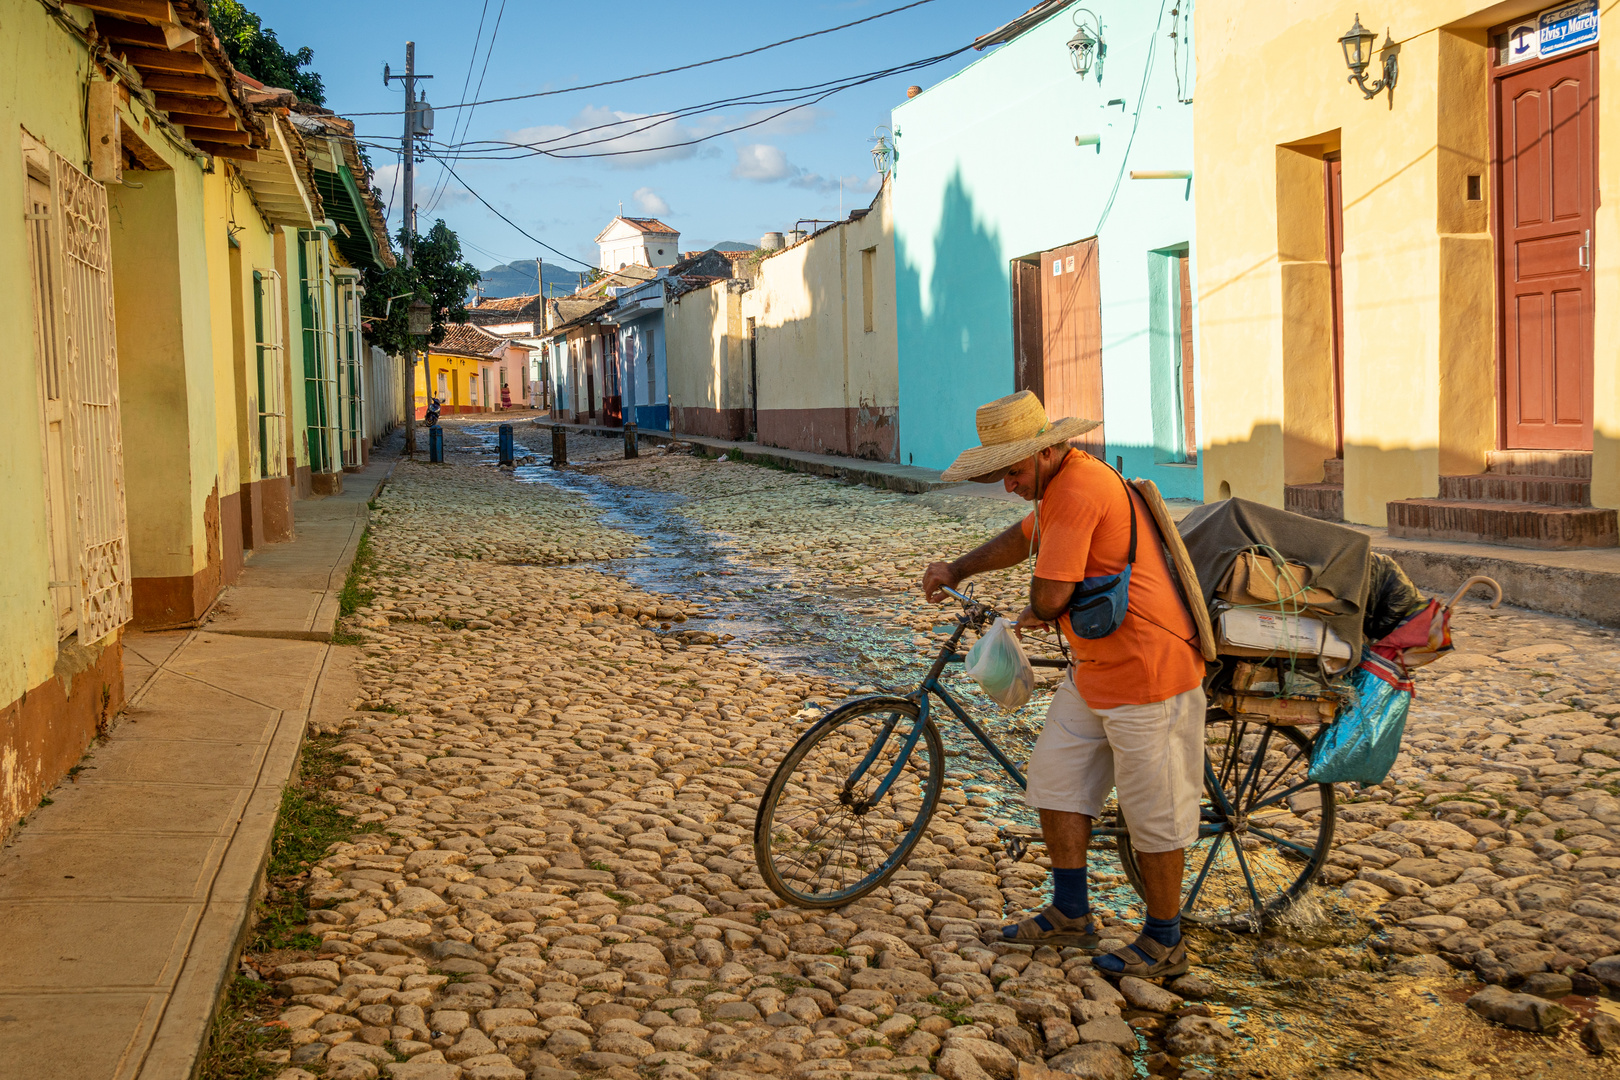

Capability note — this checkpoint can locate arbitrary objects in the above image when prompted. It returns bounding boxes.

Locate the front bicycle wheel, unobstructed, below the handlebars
[753,698,944,908]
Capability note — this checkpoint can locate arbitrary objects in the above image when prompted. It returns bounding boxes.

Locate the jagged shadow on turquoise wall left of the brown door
[894,172,1013,468]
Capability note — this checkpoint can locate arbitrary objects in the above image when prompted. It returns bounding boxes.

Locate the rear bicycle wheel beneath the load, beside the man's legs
[1119,717,1335,931]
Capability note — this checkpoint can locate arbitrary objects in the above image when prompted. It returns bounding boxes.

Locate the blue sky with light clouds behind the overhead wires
[248,0,1032,267]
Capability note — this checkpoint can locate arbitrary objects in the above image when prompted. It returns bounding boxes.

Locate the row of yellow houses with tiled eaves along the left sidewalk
[0,0,386,837]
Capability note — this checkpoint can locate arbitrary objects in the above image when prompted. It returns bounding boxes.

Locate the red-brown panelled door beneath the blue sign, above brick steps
[1497,50,1597,450]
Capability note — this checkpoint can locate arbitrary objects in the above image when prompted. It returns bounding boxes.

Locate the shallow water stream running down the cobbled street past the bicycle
[437,423,1615,1080]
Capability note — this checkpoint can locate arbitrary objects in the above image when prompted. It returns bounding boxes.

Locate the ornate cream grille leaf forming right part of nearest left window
[50,154,133,643]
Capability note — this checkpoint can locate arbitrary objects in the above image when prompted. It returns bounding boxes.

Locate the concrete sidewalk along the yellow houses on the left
[0,458,392,1080]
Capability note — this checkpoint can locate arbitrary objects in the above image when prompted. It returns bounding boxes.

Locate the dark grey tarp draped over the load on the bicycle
[1178,499,1372,656]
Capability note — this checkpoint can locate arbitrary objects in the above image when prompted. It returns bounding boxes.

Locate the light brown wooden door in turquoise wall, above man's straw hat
[1040,236,1105,457]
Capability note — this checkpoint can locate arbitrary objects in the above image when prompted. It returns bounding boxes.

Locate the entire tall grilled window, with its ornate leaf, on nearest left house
[23,136,133,641]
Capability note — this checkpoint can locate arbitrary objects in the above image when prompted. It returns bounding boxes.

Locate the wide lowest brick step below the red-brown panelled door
[1387,499,1620,549]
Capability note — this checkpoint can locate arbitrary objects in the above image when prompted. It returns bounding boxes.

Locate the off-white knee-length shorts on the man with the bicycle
[1024,669,1205,853]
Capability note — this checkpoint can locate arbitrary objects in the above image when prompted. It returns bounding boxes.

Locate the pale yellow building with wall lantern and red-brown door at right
[1194,0,1620,547]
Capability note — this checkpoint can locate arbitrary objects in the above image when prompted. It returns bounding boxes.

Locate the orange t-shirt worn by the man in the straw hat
[1024,450,1204,709]
